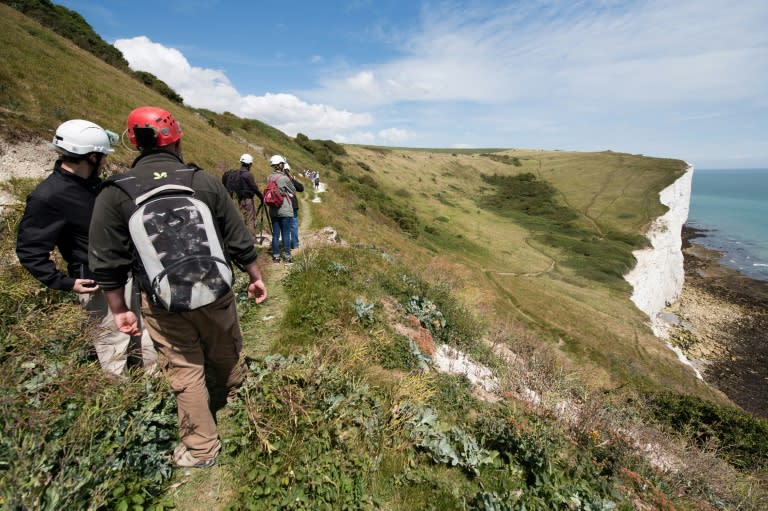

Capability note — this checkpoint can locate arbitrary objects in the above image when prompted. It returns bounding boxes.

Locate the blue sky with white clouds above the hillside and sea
[56,0,768,168]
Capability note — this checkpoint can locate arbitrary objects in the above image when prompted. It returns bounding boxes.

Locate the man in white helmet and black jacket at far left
[16,119,157,376]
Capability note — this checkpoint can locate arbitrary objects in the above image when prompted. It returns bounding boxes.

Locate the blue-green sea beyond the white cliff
[686,168,768,282]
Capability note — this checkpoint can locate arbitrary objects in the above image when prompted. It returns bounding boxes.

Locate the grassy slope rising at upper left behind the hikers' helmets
[0,5,296,173]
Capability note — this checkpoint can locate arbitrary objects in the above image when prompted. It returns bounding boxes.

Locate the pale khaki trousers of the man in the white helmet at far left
[77,279,157,376]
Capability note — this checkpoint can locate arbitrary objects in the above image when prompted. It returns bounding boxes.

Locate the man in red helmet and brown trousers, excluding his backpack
[89,106,267,468]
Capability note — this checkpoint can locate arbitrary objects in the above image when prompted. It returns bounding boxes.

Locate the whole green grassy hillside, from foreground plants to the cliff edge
[0,5,766,511]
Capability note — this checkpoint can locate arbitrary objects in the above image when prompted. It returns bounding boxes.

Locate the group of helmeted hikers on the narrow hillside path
[16,106,282,468]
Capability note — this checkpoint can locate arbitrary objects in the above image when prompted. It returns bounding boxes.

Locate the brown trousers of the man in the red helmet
[141,291,245,460]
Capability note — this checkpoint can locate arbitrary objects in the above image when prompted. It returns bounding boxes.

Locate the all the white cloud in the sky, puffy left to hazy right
[109,0,768,162]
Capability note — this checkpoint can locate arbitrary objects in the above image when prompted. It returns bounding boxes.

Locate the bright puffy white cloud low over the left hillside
[114,36,373,138]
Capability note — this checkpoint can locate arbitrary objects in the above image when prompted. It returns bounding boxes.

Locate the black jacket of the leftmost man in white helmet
[16,161,101,291]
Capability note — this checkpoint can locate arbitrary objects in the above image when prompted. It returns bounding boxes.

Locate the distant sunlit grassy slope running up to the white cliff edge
[327,146,708,395]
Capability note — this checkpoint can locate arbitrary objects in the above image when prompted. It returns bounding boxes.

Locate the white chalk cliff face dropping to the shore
[624,165,693,339]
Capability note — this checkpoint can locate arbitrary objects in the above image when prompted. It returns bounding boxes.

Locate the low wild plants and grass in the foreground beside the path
[0,216,766,510]
